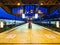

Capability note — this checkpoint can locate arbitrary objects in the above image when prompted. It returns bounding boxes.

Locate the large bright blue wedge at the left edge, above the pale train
[0,7,22,20]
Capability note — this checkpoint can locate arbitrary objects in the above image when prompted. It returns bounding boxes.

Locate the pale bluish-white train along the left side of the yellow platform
[0,19,25,28]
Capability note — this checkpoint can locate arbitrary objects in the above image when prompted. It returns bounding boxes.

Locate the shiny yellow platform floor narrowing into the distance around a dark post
[0,23,60,45]
